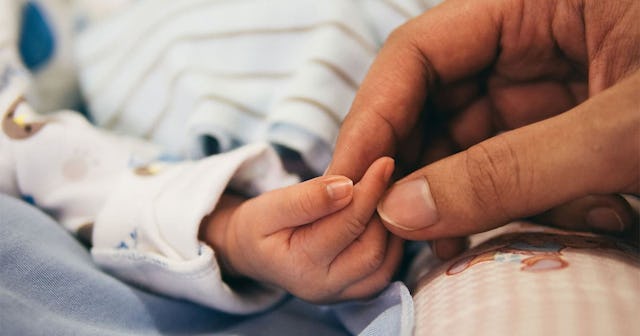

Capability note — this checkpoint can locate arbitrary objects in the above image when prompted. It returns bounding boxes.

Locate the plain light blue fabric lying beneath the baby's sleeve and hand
[0,195,413,335]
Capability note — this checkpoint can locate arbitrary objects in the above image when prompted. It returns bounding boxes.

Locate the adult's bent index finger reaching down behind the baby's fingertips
[327,0,503,181]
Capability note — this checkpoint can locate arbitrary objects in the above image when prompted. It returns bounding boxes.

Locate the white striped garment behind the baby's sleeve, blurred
[22,0,438,171]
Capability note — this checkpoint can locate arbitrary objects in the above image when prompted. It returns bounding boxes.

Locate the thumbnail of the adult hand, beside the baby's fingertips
[378,177,439,231]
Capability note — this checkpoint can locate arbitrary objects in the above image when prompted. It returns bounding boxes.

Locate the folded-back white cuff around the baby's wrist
[91,144,297,313]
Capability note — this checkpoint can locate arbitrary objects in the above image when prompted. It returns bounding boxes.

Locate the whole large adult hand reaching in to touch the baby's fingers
[327,0,640,258]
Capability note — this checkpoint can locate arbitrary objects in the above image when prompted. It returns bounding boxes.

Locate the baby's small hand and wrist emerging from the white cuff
[200,158,402,303]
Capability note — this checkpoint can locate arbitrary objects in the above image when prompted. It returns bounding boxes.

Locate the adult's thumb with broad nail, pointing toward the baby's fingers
[378,76,640,239]
